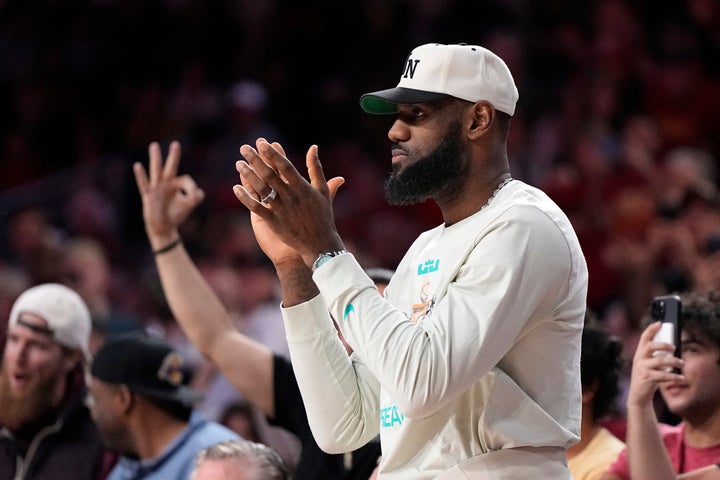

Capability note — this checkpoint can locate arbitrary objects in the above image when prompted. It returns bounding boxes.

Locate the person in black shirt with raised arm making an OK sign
[134,142,387,480]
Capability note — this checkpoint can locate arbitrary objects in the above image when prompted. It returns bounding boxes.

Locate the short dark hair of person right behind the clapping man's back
[580,313,623,420]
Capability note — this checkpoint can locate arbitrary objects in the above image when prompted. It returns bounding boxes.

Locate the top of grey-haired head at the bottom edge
[190,439,294,480]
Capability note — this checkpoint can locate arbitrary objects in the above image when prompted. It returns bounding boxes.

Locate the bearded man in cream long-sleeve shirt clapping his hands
[234,44,588,480]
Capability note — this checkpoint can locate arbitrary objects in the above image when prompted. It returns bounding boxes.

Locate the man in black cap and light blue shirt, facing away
[89,332,238,480]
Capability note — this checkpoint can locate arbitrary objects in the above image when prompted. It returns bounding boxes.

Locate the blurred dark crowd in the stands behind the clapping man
[0,0,720,450]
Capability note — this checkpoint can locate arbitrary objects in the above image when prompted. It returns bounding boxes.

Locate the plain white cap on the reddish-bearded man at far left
[8,283,92,359]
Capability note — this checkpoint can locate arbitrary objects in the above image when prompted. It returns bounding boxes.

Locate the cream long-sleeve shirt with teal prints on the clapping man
[283,180,588,480]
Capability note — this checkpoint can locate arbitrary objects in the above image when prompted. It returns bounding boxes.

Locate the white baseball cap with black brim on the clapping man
[360,43,519,116]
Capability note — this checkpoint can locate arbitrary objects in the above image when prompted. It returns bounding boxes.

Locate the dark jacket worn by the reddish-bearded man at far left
[0,372,114,480]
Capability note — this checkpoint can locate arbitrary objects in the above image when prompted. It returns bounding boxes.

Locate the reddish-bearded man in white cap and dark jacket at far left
[0,284,114,480]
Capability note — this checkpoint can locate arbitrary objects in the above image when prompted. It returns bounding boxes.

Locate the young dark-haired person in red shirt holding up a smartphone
[604,290,720,480]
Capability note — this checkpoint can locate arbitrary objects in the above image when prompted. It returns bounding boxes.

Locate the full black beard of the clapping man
[384,122,468,205]
